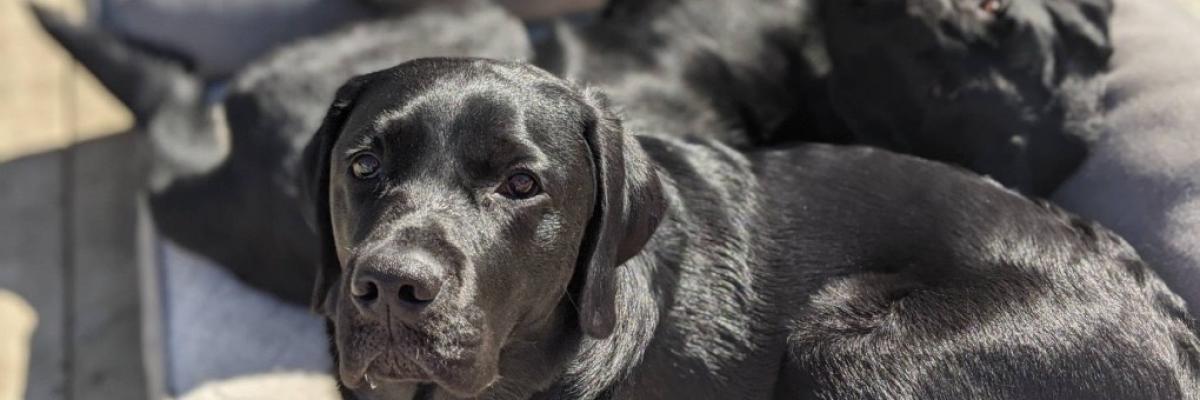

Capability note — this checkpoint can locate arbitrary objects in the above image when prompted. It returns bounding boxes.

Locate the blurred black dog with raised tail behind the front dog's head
[35,0,533,304]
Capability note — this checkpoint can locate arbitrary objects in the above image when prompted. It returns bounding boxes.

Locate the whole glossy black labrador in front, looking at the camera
[302,59,1200,399]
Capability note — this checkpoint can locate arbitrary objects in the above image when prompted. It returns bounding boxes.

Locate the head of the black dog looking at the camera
[294,59,665,396]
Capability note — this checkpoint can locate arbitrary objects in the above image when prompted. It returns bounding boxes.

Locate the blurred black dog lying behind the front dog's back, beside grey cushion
[538,0,1112,196]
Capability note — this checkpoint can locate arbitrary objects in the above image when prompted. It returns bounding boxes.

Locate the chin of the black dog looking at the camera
[338,343,499,398]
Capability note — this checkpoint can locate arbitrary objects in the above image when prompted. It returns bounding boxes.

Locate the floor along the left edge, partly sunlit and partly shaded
[0,0,145,400]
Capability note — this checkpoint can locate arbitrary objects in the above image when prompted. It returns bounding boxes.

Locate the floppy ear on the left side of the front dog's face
[298,74,371,312]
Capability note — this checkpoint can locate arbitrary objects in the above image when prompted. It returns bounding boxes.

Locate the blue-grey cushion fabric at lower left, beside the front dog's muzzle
[160,241,336,399]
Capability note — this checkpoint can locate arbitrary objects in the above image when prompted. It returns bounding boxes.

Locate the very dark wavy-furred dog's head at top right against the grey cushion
[821,0,1112,196]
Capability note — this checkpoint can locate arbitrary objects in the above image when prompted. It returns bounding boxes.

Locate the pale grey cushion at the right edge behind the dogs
[1055,0,1200,315]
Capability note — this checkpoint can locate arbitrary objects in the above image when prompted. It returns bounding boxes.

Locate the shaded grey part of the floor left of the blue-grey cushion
[0,135,145,400]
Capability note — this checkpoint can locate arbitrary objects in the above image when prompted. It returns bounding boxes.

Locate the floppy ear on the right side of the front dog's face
[576,89,666,339]
